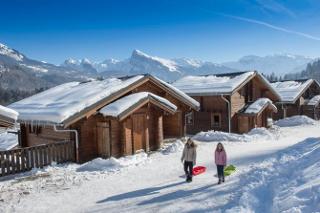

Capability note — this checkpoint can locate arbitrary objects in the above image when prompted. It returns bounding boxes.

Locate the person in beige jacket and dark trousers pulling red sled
[181,138,197,182]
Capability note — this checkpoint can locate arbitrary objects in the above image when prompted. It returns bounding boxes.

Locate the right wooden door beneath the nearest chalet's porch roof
[132,114,146,153]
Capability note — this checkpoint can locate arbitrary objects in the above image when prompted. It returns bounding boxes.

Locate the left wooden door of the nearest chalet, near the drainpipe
[97,122,111,158]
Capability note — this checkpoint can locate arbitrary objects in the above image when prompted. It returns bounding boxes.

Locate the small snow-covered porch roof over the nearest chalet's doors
[99,92,177,117]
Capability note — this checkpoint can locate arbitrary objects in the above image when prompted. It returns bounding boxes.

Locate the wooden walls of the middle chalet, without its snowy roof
[187,74,279,134]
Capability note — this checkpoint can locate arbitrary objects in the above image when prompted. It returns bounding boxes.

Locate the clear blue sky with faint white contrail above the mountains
[0,0,320,64]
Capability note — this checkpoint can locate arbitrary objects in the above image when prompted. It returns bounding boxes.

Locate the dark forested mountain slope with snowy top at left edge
[0,44,90,91]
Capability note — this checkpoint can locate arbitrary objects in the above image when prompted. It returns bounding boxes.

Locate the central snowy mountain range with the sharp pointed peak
[62,50,238,81]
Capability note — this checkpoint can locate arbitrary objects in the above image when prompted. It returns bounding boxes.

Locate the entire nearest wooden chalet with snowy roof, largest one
[11,75,199,162]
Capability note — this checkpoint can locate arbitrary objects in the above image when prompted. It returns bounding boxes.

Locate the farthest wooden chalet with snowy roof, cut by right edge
[272,79,320,120]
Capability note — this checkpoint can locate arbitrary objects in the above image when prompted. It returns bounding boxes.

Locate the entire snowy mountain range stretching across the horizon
[0,41,312,90]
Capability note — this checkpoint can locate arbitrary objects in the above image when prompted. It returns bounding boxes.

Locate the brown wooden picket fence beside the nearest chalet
[0,141,75,176]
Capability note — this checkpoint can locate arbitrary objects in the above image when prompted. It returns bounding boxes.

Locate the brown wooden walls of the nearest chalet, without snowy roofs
[21,76,198,162]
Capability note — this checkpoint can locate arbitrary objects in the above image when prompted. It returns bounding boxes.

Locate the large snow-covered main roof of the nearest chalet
[9,75,199,124]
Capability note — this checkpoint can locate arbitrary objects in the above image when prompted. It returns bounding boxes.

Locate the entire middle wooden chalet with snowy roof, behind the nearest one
[173,71,280,134]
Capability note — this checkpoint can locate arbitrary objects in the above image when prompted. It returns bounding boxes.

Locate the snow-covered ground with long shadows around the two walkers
[0,118,320,212]
